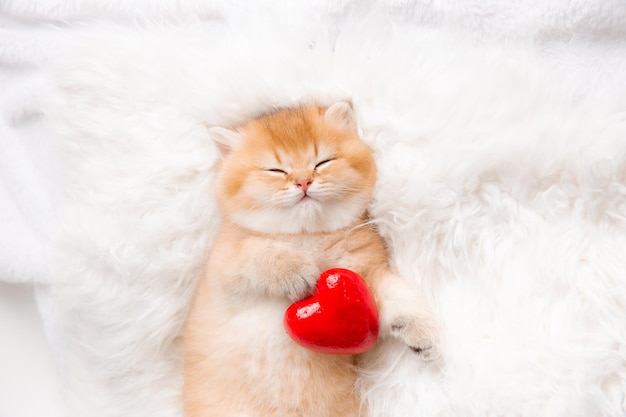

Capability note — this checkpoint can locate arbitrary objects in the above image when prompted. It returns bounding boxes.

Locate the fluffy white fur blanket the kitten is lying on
[0,0,626,417]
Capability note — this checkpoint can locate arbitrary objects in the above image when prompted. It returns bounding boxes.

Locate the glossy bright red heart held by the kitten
[283,268,378,354]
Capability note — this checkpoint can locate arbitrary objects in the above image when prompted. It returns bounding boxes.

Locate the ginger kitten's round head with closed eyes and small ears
[210,102,376,233]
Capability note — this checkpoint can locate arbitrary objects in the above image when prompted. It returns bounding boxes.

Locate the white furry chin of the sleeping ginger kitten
[229,199,367,234]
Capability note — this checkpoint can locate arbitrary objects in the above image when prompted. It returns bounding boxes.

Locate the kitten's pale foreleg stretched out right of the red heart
[373,272,440,361]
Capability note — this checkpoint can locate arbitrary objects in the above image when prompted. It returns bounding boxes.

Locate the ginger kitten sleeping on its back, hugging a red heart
[183,102,438,417]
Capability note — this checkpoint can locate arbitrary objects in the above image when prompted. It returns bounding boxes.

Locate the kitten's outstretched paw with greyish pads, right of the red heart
[391,316,441,362]
